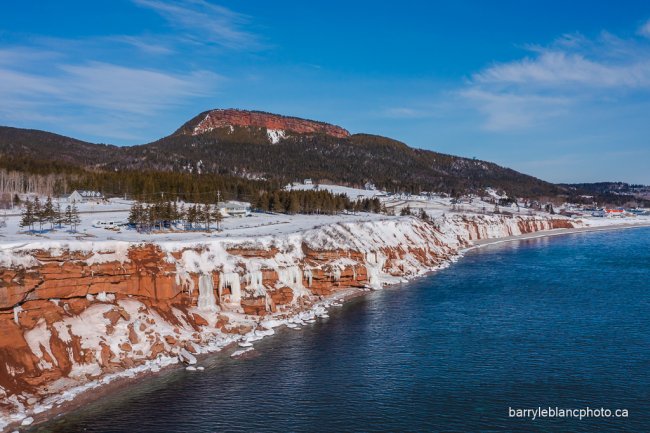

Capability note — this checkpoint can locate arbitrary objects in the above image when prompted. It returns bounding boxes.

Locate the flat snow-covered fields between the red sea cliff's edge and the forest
[0,193,650,249]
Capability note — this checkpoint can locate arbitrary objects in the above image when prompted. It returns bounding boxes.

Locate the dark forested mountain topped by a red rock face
[0,109,565,197]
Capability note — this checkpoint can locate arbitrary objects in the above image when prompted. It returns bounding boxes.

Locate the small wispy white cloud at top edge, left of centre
[133,0,260,49]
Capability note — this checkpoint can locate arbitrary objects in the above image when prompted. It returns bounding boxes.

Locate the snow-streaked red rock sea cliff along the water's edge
[0,215,575,429]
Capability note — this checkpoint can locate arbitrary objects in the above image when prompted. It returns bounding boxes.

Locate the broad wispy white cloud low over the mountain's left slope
[0,52,222,139]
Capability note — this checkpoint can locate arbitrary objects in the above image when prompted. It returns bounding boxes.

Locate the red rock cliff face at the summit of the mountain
[184,109,350,138]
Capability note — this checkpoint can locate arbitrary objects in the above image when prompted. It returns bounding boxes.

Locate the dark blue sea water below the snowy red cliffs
[35,229,650,433]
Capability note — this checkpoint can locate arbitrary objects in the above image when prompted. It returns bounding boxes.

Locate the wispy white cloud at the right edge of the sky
[458,32,650,131]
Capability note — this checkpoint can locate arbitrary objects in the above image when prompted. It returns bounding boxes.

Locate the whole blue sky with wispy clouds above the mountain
[0,0,650,184]
